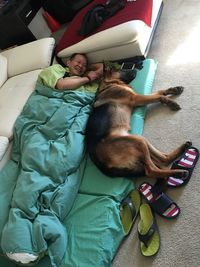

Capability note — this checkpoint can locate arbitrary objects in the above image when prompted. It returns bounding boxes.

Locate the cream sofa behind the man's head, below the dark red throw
[57,0,163,62]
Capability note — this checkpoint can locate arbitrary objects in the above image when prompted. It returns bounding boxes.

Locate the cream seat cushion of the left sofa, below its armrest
[0,70,41,139]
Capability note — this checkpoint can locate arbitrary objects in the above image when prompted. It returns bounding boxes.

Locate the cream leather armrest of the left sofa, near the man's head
[1,37,55,77]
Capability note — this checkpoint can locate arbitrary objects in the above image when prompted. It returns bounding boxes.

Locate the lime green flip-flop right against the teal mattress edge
[120,189,141,235]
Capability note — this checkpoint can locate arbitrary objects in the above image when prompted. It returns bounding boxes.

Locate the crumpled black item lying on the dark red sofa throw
[79,0,125,36]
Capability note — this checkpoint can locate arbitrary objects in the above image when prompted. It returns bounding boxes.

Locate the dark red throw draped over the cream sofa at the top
[56,0,153,53]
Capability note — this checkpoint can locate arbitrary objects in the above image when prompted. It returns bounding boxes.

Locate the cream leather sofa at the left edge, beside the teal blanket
[0,37,55,169]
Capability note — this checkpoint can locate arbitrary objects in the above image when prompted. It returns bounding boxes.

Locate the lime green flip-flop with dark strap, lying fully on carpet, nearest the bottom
[138,204,160,257]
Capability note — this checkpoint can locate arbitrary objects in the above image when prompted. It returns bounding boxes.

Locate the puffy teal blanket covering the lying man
[0,83,94,266]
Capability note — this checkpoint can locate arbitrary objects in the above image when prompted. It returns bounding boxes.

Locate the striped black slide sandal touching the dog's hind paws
[167,146,199,188]
